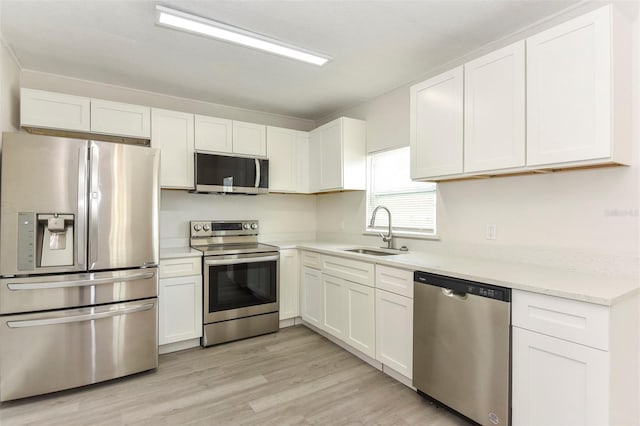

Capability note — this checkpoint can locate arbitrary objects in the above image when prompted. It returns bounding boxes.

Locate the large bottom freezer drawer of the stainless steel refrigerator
[0,298,158,401]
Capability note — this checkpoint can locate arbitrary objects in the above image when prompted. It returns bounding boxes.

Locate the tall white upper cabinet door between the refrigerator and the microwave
[151,108,194,189]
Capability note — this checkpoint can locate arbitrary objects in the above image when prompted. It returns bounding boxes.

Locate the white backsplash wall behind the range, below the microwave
[160,190,316,247]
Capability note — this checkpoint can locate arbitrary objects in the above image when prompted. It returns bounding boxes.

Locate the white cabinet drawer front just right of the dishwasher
[512,290,609,350]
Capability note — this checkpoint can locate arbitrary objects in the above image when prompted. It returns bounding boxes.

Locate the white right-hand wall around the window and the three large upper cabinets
[317,1,640,277]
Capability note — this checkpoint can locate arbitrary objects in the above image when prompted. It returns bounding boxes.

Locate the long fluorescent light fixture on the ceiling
[156,5,331,66]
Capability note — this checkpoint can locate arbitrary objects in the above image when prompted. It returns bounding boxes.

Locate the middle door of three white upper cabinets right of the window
[464,41,525,172]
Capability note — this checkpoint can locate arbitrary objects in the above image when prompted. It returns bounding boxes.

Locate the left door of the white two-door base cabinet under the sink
[322,274,347,340]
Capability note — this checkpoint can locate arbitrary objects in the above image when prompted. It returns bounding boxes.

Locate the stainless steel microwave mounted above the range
[194,152,269,194]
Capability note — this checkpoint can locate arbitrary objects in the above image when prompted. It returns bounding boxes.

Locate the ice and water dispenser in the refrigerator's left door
[18,212,75,270]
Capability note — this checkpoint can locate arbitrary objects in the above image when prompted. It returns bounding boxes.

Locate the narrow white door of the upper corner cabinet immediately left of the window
[315,120,343,191]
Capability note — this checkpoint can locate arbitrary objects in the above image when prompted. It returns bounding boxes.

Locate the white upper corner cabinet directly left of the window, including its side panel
[309,117,366,192]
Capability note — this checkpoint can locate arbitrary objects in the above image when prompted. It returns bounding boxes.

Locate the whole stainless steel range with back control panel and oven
[190,220,280,346]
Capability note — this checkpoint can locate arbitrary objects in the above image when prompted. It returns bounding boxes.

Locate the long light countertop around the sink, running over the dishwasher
[266,241,640,305]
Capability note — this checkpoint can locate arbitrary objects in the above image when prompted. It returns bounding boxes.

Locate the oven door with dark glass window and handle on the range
[203,252,280,324]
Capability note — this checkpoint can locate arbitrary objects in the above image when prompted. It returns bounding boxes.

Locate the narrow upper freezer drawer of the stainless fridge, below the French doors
[0,268,158,315]
